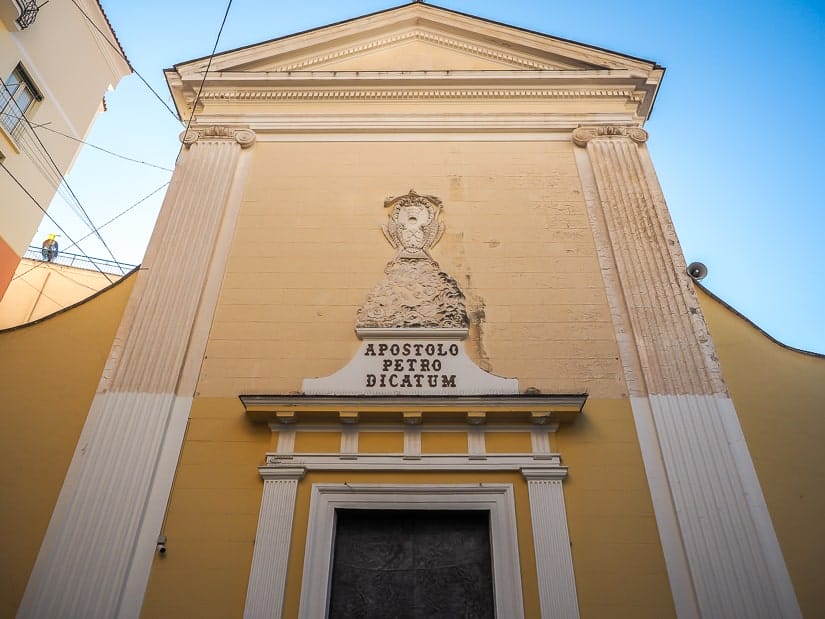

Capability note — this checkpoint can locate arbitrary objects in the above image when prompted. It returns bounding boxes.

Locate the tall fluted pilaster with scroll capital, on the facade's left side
[18,128,254,618]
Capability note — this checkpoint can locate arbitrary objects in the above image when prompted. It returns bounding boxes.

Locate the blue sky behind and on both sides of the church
[35,0,825,352]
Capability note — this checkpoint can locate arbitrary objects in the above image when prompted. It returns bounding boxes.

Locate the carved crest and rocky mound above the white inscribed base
[356,190,470,329]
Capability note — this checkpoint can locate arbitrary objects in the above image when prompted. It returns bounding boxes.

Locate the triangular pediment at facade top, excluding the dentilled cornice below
[176,2,653,74]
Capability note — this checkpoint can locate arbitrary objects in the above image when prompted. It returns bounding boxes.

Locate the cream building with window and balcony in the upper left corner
[0,0,131,297]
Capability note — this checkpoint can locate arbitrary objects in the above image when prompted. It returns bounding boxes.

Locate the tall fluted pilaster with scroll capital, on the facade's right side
[573,126,799,619]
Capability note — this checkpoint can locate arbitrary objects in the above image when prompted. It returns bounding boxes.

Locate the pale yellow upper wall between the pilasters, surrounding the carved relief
[198,141,625,397]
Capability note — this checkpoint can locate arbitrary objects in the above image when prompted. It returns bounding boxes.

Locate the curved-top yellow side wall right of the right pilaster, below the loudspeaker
[699,289,825,617]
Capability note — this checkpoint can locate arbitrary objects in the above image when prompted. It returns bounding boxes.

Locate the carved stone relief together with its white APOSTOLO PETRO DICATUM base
[302,190,518,396]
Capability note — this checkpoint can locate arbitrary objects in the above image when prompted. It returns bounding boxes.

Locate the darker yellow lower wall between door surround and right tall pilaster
[551,400,675,619]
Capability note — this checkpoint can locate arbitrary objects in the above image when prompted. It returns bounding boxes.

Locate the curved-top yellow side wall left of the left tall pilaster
[0,276,135,617]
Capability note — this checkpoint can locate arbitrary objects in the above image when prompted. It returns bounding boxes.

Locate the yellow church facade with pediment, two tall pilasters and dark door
[0,3,821,619]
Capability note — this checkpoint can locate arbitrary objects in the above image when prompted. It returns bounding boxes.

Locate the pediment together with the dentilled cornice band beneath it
[166,3,664,119]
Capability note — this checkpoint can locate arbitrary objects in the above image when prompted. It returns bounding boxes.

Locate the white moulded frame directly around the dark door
[298,484,524,619]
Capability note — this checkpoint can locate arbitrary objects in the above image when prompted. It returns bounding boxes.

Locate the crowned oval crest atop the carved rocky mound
[381,189,444,260]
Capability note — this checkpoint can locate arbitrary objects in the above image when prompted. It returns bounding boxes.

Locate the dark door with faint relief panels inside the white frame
[329,509,495,619]
